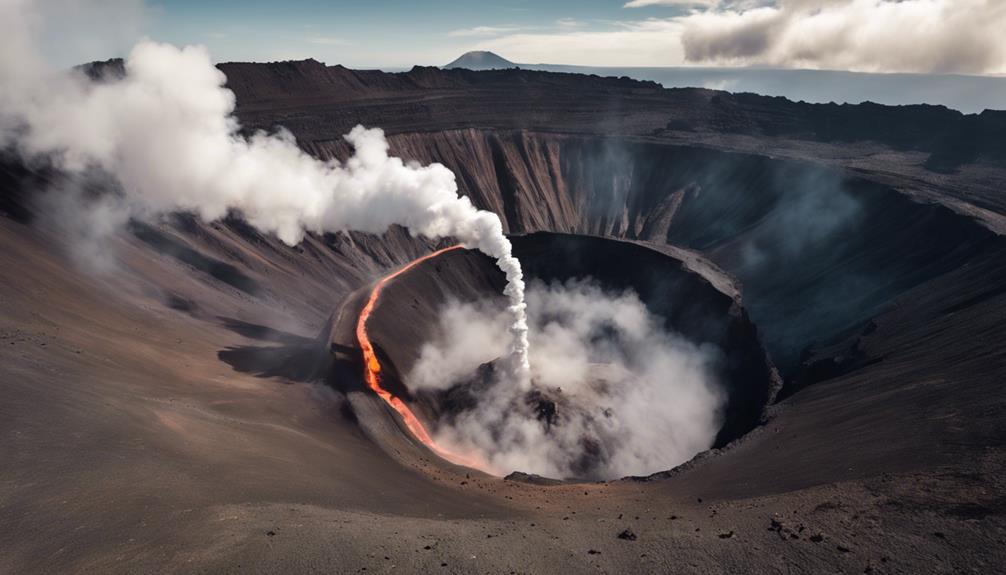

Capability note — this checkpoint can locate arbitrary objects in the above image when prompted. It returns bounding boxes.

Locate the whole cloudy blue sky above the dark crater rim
[27,0,1006,75]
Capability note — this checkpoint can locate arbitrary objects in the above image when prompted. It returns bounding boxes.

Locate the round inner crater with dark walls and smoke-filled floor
[367,232,780,481]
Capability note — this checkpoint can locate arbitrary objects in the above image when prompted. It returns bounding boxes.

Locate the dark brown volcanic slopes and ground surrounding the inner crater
[0,62,1006,573]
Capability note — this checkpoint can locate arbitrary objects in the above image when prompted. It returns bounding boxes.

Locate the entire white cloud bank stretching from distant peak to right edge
[477,0,1006,74]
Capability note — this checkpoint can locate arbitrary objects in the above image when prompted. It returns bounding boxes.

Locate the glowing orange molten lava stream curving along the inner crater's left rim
[356,245,484,467]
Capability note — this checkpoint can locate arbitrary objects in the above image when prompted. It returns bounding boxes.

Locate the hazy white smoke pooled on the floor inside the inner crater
[405,281,725,480]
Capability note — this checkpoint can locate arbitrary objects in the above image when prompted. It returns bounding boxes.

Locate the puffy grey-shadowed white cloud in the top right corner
[679,0,1006,73]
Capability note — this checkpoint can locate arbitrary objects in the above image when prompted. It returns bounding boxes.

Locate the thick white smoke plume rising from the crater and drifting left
[0,0,528,382]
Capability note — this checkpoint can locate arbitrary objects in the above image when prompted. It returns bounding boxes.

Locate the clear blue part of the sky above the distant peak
[143,0,684,66]
